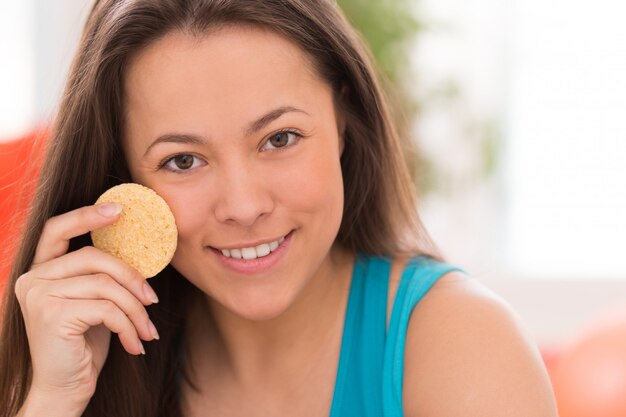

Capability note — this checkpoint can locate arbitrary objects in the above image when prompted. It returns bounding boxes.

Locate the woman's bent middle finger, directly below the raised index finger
[28,246,159,305]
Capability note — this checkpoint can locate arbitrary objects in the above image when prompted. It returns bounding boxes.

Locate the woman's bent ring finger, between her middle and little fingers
[44,274,159,341]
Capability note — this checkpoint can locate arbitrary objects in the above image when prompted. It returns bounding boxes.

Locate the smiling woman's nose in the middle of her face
[215,163,274,226]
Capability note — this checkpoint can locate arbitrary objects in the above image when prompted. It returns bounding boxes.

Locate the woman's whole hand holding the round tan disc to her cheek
[15,204,158,412]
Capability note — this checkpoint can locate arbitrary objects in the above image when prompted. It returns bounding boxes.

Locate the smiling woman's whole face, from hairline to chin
[124,27,343,319]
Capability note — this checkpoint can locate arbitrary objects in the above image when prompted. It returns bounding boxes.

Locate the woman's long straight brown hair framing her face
[0,0,436,417]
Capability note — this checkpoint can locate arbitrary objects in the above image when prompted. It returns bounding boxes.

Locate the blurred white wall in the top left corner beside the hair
[0,0,92,140]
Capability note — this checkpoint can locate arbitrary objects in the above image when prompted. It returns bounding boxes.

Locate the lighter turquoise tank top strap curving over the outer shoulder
[382,257,460,417]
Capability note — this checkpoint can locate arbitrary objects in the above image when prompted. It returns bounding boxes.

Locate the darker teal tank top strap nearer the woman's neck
[330,255,391,417]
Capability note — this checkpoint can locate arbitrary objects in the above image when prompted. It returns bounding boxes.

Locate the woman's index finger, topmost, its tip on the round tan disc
[33,203,122,265]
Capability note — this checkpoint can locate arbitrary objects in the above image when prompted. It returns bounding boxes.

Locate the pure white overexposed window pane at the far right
[506,0,626,278]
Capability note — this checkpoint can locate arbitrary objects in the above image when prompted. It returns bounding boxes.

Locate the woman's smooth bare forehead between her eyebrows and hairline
[125,26,332,150]
